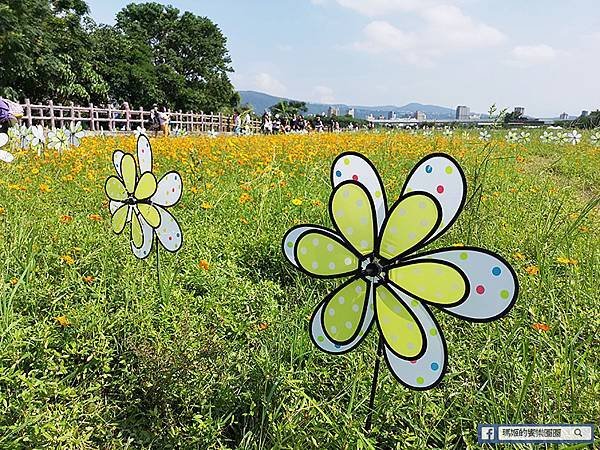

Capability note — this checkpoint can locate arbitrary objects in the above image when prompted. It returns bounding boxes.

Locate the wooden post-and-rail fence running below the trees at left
[22,99,260,133]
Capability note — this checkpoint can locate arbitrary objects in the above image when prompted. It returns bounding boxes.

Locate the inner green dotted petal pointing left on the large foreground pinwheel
[296,231,359,277]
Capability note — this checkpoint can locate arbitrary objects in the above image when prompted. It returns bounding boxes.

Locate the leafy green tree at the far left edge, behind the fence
[0,0,108,102]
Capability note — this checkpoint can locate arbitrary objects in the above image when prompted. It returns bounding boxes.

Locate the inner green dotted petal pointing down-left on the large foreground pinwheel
[323,278,369,344]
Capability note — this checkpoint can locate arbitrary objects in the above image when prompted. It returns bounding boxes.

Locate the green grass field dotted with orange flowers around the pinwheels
[0,132,600,449]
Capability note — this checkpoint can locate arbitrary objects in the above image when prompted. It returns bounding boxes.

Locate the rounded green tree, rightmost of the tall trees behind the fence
[115,3,239,111]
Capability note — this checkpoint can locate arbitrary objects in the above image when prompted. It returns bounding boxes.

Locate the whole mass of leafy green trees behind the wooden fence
[0,0,239,112]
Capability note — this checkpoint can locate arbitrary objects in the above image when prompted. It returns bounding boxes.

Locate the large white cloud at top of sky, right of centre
[337,0,506,66]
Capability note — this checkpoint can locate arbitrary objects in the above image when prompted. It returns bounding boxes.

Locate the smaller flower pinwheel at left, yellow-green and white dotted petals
[104,135,183,259]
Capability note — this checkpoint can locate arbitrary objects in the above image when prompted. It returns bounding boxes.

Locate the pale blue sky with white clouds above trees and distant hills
[88,0,600,116]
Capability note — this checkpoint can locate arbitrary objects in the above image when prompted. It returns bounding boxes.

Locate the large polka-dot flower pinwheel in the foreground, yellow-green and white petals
[283,153,518,389]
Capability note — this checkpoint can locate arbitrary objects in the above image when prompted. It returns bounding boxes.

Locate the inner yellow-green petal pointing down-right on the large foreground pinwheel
[375,285,425,359]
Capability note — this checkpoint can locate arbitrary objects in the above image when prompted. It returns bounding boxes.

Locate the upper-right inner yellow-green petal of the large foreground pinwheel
[379,193,440,259]
